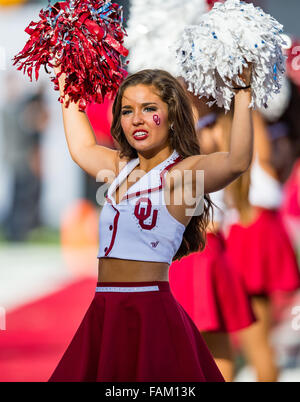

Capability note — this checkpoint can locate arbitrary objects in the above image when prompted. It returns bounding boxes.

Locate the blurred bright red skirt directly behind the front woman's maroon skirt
[170,233,255,332]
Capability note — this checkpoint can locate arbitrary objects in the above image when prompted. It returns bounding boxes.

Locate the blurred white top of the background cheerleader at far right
[249,157,282,209]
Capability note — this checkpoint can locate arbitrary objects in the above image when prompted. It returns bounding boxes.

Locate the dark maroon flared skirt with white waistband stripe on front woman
[49,282,224,382]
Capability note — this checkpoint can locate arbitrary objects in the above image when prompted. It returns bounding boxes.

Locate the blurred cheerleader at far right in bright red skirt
[227,112,300,381]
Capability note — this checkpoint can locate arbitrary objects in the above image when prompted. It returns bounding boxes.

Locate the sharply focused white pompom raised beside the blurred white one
[175,0,285,110]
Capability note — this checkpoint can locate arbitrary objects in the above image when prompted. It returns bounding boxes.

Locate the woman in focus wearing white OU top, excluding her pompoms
[50,63,252,381]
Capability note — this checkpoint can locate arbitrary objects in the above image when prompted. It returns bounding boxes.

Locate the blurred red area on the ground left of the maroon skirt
[0,278,97,382]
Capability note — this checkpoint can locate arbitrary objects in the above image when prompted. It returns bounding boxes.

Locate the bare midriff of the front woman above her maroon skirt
[98,258,169,282]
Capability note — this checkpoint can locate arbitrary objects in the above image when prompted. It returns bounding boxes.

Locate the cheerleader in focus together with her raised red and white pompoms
[15,0,284,381]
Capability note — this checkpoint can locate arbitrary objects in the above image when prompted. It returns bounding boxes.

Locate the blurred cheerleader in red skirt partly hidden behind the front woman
[170,93,255,381]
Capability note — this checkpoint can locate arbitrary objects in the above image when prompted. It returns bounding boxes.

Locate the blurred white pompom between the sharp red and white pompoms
[125,0,207,76]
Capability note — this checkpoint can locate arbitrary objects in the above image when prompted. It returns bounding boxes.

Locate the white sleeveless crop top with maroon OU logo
[98,151,185,264]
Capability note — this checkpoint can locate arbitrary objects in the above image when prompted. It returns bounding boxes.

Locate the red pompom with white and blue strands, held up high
[14,0,128,111]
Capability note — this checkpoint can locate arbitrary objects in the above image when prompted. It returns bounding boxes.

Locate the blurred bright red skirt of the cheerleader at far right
[227,209,300,296]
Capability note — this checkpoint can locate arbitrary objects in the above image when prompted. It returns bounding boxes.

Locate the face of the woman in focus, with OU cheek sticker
[121,84,170,152]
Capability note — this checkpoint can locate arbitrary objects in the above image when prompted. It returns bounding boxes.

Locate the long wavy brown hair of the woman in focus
[111,70,212,261]
